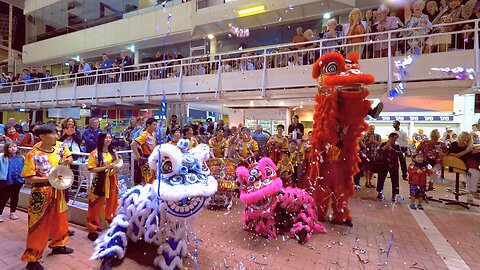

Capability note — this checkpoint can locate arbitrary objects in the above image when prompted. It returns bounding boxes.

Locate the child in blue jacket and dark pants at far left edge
[0,142,24,222]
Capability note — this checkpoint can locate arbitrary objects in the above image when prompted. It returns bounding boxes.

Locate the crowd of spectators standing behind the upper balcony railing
[0,0,480,90]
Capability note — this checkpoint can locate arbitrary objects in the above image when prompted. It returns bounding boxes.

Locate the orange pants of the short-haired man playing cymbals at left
[21,186,68,262]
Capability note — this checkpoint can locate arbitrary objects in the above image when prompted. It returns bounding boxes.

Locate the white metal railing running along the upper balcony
[0,17,480,104]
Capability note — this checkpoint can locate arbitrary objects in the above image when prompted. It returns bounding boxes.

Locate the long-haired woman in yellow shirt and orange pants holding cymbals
[87,133,119,241]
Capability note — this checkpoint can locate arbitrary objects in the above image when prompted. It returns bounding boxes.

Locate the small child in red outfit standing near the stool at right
[408,152,433,210]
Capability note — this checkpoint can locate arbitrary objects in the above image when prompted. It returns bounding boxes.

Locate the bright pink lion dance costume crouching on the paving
[236,158,327,243]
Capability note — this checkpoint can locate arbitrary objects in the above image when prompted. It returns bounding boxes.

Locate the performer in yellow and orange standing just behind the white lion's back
[130,118,157,184]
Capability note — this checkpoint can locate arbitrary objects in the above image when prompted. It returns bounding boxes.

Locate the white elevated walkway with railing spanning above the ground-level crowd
[0,20,480,109]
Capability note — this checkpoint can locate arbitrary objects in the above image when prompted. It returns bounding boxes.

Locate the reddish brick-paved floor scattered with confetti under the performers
[0,175,480,270]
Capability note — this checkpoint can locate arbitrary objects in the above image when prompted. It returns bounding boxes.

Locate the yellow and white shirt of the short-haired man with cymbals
[22,142,72,177]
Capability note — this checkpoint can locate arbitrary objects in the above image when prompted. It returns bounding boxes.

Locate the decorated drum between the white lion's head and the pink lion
[207,158,238,191]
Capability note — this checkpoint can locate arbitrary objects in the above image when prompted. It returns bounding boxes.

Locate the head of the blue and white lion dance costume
[148,144,217,218]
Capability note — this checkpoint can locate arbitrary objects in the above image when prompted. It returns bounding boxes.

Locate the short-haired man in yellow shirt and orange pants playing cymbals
[21,124,73,270]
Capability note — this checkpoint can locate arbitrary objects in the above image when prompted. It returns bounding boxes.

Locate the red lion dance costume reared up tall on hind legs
[309,52,381,226]
